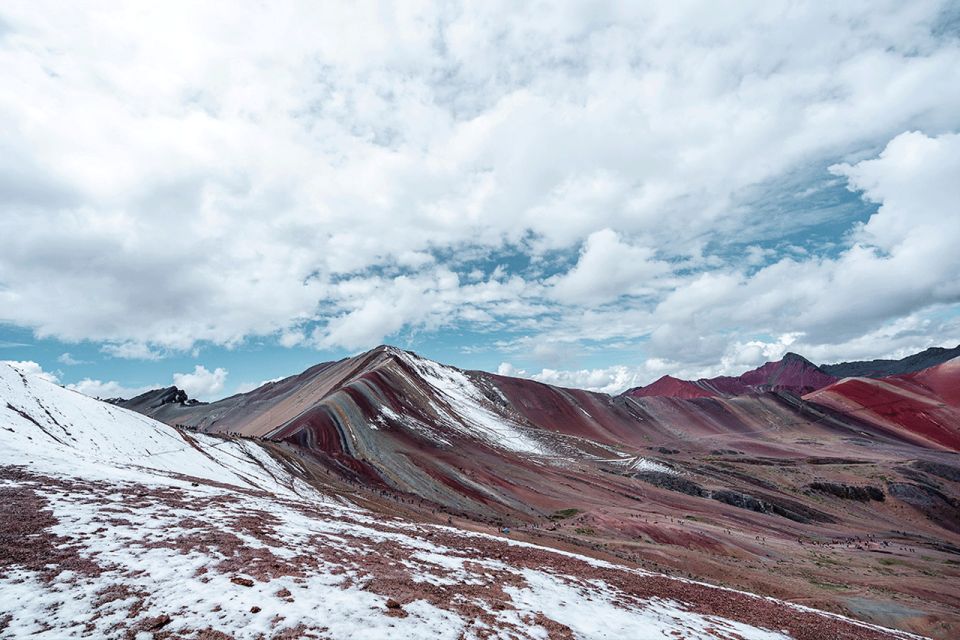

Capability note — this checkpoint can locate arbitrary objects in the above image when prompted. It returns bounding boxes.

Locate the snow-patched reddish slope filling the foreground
[0,364,905,639]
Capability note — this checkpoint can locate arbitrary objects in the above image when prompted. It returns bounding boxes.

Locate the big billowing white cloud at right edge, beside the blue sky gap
[656,133,960,350]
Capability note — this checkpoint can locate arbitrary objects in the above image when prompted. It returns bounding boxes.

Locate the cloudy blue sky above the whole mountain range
[0,0,960,400]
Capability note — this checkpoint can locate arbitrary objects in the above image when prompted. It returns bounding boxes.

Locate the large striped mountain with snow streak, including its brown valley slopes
[109,346,960,637]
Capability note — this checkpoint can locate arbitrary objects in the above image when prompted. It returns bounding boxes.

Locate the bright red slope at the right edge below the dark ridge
[804,358,960,451]
